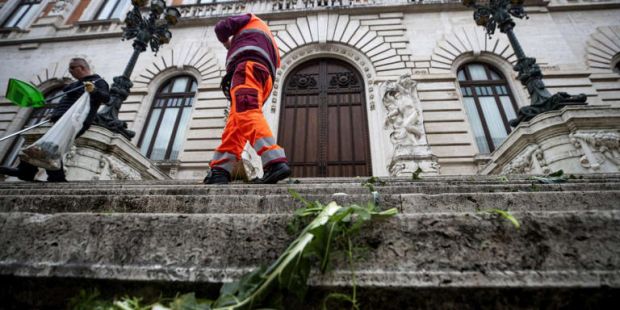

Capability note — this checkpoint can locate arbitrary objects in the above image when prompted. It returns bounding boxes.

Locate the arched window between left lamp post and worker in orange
[139,75,197,160]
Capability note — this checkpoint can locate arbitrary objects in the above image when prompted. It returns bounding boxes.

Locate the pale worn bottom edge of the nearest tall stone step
[0,262,620,288]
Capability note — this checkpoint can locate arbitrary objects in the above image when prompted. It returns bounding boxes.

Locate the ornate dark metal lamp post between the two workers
[95,0,181,139]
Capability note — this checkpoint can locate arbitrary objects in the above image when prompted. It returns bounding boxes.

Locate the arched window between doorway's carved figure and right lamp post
[458,63,517,153]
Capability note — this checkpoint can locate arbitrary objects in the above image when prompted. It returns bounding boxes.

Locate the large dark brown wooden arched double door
[278,58,372,177]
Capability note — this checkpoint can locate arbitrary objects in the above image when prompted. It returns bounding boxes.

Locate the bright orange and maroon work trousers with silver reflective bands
[209,61,287,173]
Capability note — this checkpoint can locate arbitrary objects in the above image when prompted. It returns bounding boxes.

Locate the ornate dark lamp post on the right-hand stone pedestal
[462,0,587,127]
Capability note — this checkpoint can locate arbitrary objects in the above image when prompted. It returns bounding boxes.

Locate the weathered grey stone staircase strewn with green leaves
[0,174,620,309]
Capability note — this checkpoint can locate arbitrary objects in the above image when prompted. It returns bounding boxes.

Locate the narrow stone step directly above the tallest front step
[0,190,620,214]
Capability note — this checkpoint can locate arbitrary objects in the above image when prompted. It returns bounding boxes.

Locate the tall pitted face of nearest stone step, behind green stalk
[0,210,620,287]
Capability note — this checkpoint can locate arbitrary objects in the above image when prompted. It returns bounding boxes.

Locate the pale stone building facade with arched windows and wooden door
[0,0,620,179]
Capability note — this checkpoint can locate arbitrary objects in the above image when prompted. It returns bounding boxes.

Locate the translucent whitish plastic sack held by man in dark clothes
[19,92,90,171]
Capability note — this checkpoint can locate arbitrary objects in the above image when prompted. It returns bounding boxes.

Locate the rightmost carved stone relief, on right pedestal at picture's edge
[570,131,620,171]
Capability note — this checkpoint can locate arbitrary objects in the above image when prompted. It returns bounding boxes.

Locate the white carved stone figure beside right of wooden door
[380,75,439,176]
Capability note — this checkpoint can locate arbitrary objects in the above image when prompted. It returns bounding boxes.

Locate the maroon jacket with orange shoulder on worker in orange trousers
[215,13,278,78]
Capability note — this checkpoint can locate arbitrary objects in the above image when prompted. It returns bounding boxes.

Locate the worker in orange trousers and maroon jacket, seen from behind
[204,14,291,184]
